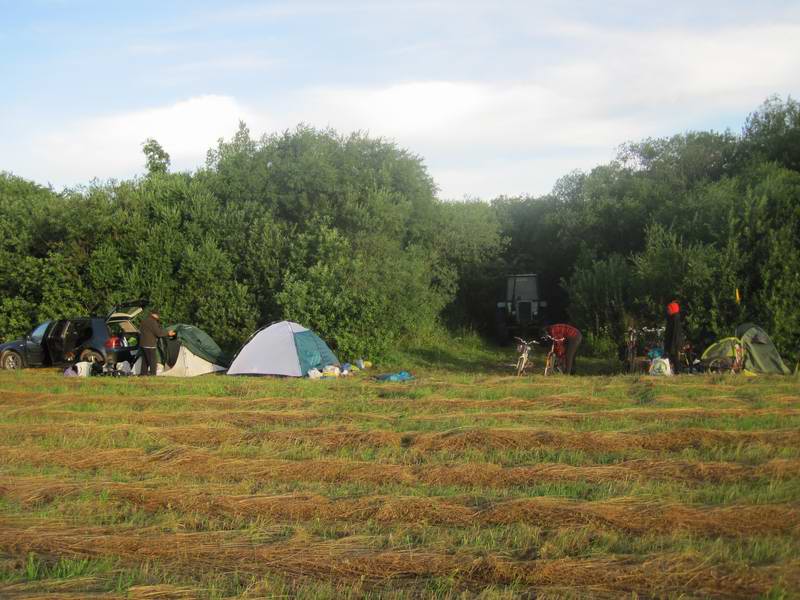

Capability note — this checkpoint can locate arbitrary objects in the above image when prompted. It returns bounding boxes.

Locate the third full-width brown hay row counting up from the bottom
[0,446,800,488]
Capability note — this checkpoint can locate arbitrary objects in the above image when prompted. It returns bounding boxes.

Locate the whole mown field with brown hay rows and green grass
[0,353,800,599]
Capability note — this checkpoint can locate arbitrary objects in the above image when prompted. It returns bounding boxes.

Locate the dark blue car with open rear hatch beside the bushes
[0,300,147,369]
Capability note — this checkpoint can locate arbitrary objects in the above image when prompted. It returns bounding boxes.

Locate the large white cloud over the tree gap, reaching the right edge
[289,19,800,198]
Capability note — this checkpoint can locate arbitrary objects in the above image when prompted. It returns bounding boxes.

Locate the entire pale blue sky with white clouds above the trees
[0,0,800,199]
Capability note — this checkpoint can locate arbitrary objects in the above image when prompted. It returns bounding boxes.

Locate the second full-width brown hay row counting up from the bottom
[0,477,800,537]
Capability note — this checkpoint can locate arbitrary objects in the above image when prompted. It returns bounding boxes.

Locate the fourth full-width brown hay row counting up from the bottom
[7,421,800,454]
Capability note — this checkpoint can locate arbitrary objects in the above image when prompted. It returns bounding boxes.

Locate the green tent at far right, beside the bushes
[701,323,791,375]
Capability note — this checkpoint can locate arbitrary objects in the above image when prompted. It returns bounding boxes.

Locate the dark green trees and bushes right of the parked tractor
[494,98,800,356]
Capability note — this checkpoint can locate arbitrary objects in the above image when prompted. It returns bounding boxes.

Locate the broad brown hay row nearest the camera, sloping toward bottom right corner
[0,520,800,598]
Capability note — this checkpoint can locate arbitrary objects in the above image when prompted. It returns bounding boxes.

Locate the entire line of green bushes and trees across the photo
[0,98,800,356]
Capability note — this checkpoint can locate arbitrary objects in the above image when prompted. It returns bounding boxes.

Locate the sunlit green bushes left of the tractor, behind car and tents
[0,124,503,357]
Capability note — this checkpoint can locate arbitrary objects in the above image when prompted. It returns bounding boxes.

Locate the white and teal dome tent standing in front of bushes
[228,321,339,377]
